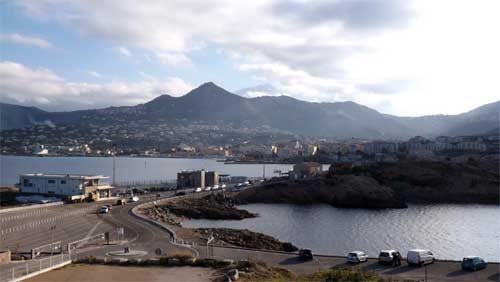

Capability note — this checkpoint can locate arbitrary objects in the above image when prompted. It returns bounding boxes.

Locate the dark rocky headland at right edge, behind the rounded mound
[354,158,500,205]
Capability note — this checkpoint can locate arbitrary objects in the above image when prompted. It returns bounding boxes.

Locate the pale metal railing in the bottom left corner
[0,253,71,282]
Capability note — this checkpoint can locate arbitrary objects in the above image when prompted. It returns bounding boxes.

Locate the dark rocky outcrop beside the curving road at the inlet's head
[157,194,257,219]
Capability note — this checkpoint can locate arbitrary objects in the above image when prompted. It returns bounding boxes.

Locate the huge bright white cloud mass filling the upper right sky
[10,0,500,115]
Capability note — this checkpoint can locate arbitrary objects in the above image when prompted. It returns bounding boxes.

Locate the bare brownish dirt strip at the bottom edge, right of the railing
[25,264,215,282]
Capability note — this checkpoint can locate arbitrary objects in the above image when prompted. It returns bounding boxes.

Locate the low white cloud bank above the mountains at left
[0,61,193,111]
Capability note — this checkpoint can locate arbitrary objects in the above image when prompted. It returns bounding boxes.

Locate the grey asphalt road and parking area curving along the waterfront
[0,188,500,281]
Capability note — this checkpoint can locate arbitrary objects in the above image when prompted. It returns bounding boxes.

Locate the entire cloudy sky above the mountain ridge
[0,0,500,116]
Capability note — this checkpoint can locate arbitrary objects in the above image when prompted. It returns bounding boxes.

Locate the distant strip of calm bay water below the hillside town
[0,156,292,185]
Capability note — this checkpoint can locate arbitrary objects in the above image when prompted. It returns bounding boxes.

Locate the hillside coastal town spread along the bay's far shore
[0,122,500,164]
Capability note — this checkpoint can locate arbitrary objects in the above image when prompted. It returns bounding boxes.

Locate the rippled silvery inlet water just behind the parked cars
[184,204,500,262]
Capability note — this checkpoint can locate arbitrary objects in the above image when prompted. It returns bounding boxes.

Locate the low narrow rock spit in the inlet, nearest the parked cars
[194,228,298,252]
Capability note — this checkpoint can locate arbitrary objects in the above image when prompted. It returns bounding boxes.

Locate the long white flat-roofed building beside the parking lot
[17,173,113,201]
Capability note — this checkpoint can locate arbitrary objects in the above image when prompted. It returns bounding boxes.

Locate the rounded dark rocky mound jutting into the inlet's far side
[234,175,406,209]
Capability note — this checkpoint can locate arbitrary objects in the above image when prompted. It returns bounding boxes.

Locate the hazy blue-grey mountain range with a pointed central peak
[2,82,500,139]
